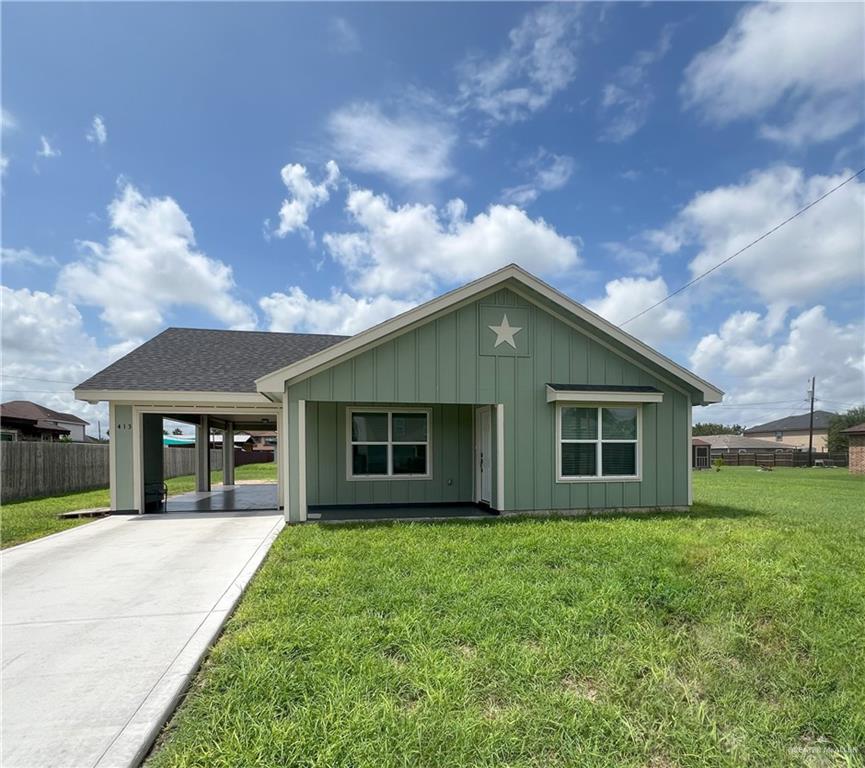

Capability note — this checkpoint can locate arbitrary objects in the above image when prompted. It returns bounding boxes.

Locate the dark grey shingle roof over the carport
[76,328,348,392]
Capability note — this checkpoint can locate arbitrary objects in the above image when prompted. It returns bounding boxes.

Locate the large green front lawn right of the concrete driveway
[149,468,865,768]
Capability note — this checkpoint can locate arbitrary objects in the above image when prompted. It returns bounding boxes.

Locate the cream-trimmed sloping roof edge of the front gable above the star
[256,264,724,404]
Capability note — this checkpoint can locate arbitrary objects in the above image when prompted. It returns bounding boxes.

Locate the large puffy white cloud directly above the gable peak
[323,184,580,297]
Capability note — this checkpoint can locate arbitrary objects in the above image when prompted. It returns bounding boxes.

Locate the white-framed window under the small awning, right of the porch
[556,403,643,483]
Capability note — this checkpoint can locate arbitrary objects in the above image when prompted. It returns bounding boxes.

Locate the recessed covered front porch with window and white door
[284,399,504,522]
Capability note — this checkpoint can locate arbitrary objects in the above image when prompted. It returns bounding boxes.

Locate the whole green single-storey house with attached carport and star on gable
[75,265,723,522]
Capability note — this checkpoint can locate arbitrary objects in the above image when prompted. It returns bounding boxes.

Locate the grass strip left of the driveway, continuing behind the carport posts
[0,463,276,548]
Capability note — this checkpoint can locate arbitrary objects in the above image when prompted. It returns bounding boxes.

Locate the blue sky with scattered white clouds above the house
[0,2,865,433]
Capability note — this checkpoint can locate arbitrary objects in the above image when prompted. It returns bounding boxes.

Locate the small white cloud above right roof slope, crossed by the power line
[585,277,688,345]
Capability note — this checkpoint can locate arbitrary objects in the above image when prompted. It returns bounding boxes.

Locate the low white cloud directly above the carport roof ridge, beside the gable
[259,286,414,336]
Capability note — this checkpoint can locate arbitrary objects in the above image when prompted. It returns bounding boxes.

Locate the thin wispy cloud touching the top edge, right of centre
[459,3,581,123]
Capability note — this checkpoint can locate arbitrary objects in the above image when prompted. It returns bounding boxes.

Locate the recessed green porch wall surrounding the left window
[306,402,474,505]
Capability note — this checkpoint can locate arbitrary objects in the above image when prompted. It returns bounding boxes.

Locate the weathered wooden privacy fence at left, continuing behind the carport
[0,441,222,502]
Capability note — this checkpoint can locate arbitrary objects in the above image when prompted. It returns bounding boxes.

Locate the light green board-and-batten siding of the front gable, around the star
[288,289,690,511]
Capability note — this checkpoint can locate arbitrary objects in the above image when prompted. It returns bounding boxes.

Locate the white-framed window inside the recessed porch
[346,407,432,480]
